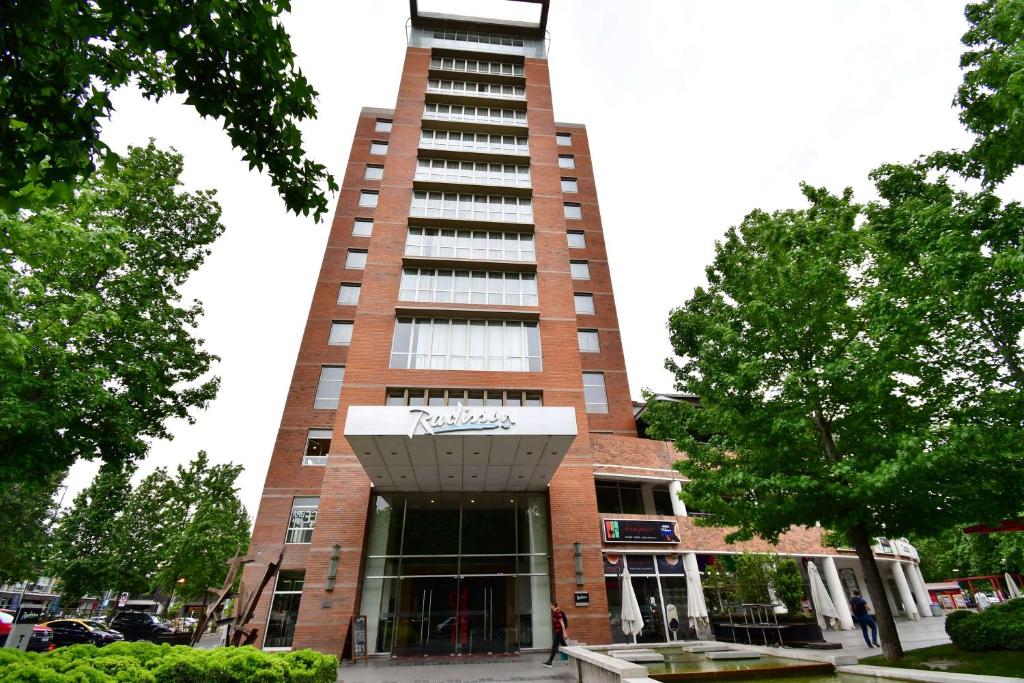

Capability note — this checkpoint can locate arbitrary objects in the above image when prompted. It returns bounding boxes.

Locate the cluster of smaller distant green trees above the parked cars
[50,452,249,600]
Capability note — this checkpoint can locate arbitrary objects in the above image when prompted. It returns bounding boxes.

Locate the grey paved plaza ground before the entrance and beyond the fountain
[338,617,949,683]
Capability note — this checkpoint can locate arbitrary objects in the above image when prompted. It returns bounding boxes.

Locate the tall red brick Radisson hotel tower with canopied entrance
[244,0,927,655]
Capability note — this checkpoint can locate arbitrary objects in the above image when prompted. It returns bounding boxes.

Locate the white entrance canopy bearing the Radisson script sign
[345,405,577,492]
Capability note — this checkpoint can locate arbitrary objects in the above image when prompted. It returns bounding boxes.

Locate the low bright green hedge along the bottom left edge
[0,642,338,683]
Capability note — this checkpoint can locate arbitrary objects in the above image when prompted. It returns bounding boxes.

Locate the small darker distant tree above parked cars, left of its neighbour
[48,465,132,602]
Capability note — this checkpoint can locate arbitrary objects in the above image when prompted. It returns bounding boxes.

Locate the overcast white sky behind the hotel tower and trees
[67,0,1007,515]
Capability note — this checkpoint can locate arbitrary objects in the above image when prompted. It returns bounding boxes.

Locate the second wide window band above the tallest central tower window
[406,227,537,263]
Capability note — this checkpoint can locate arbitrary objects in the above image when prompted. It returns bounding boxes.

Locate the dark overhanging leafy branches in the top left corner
[0,0,337,220]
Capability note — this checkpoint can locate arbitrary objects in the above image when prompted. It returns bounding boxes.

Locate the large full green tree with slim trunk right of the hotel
[647,178,1024,658]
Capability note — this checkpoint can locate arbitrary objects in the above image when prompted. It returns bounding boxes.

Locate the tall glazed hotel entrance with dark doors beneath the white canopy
[360,494,551,656]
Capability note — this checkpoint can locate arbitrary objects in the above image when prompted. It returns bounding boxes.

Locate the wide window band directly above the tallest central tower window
[398,268,537,306]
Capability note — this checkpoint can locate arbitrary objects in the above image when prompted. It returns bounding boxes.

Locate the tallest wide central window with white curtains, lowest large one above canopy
[391,317,541,373]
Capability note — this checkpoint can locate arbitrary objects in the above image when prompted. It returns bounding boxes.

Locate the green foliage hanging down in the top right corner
[956,0,1024,184]
